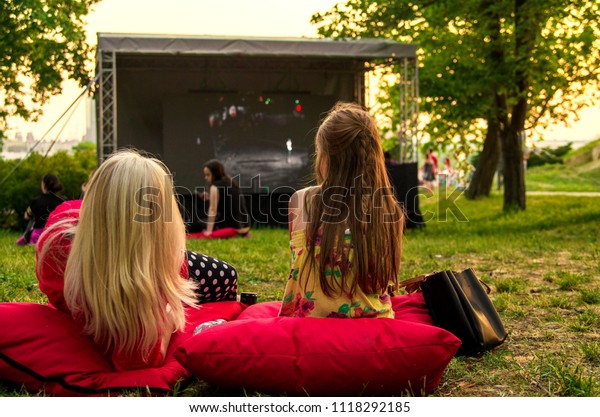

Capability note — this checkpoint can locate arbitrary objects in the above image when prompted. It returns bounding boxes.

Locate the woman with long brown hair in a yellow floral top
[279,103,404,318]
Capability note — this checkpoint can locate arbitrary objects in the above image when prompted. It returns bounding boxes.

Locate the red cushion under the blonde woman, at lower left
[0,301,244,396]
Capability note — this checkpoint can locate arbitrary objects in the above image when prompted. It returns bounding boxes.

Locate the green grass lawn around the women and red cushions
[0,191,600,397]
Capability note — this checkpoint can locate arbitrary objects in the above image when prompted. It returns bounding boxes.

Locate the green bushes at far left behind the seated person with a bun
[0,150,97,230]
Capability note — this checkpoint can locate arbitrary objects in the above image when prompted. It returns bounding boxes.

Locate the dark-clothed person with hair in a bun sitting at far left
[16,174,65,245]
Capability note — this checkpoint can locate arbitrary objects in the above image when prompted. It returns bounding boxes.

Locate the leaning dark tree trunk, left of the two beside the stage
[465,120,500,200]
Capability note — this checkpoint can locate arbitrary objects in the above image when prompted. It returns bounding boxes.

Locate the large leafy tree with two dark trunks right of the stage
[312,0,600,210]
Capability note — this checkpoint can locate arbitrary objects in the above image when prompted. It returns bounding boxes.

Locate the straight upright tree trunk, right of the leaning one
[502,129,525,211]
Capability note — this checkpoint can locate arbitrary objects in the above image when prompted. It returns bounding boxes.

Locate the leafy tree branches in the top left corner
[0,0,99,143]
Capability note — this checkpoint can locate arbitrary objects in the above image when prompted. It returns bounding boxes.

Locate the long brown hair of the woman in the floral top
[307,103,404,296]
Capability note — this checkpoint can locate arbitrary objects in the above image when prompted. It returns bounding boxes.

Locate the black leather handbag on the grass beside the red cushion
[398,268,508,356]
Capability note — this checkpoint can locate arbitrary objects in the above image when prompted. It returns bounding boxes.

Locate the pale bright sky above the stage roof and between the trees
[8,0,600,146]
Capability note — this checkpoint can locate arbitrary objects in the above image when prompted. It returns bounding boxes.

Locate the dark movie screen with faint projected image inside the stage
[178,93,335,193]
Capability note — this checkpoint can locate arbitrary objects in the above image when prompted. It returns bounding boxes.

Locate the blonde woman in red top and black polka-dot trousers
[37,151,237,370]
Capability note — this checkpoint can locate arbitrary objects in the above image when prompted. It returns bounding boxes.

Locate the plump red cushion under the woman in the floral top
[175,297,460,396]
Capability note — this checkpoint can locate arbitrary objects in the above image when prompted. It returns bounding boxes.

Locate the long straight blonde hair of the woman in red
[42,150,195,358]
